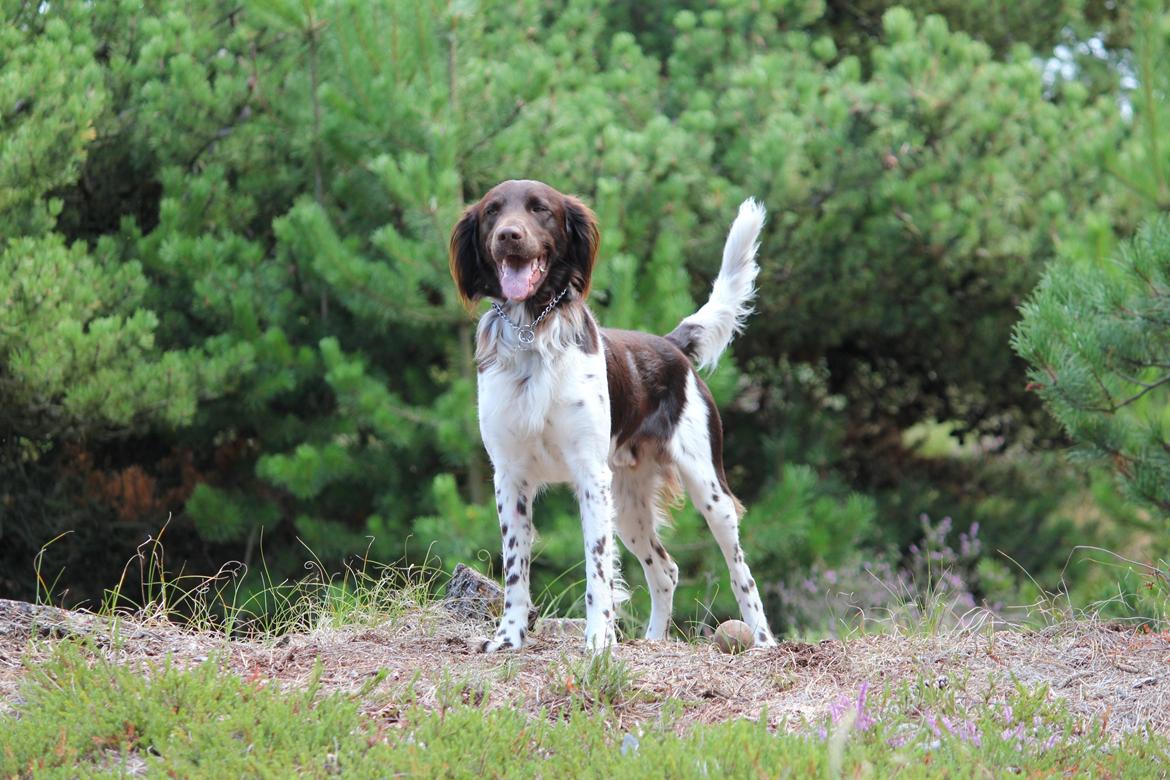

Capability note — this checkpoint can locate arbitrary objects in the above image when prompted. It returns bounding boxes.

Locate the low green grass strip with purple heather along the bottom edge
[0,643,1170,778]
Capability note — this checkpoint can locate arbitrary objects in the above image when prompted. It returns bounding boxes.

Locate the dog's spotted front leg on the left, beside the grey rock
[480,472,535,653]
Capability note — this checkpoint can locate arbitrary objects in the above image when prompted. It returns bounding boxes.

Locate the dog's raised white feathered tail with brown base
[666,198,765,368]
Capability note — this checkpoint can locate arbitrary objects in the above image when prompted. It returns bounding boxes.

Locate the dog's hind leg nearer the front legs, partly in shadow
[613,461,679,640]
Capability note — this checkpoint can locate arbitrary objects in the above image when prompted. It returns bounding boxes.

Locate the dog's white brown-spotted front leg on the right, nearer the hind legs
[577,463,618,653]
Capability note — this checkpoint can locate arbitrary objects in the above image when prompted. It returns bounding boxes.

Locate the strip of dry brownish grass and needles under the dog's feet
[0,600,1170,734]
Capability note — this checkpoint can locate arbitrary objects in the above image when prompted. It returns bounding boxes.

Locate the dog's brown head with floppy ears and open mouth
[450,180,600,306]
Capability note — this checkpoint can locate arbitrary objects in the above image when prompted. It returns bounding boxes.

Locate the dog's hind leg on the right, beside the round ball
[669,373,776,647]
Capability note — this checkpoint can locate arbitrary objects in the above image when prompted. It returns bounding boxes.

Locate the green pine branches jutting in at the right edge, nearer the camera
[1013,216,1170,515]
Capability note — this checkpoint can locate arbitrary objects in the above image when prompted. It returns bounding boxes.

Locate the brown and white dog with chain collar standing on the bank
[450,181,776,653]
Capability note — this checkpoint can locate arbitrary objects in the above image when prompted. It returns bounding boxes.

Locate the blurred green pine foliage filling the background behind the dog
[0,0,1170,624]
